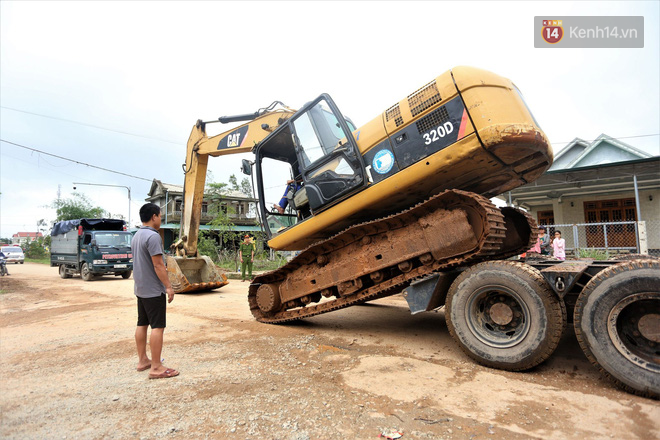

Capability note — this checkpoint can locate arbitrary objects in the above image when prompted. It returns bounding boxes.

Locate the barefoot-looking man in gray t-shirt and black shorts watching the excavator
[131,203,179,379]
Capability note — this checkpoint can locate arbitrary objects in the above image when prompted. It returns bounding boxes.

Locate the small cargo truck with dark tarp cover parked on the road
[50,218,133,281]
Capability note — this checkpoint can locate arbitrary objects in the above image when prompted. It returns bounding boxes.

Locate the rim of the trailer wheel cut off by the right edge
[607,292,660,373]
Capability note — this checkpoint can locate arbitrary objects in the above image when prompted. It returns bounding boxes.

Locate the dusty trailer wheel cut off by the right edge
[573,259,660,399]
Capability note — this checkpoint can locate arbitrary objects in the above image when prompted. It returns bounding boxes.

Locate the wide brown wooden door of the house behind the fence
[584,198,637,247]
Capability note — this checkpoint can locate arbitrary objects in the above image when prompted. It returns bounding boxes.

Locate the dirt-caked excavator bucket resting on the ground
[167,256,229,293]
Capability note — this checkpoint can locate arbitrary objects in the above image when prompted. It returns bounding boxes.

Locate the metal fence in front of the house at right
[544,221,660,258]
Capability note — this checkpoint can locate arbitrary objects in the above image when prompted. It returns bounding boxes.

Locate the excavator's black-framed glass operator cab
[255,94,367,237]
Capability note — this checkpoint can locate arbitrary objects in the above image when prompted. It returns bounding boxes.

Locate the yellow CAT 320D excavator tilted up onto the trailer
[168,67,552,306]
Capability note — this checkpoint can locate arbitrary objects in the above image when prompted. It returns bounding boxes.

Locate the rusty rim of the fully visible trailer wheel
[465,286,530,348]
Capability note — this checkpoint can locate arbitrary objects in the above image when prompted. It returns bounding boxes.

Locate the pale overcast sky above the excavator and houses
[0,1,660,237]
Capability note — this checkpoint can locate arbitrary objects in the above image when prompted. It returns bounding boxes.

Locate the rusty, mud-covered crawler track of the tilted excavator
[248,190,536,324]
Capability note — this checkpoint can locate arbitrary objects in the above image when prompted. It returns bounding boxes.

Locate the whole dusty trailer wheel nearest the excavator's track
[445,261,566,371]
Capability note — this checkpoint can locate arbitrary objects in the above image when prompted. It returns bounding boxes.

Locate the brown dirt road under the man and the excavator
[0,263,660,440]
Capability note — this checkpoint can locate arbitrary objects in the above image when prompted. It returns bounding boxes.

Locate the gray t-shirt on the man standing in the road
[131,226,165,298]
